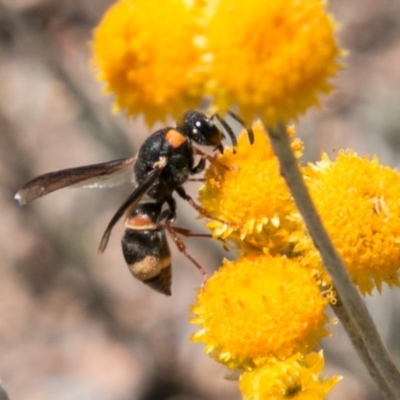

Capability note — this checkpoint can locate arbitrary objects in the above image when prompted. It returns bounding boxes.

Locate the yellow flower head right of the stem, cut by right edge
[298,152,400,294]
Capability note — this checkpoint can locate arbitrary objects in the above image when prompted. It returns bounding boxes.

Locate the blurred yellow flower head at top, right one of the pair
[207,0,343,125]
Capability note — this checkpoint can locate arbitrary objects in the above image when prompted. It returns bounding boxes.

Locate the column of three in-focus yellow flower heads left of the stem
[191,122,338,400]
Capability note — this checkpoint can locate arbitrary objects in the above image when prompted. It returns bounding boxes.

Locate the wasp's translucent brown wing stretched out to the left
[14,157,136,206]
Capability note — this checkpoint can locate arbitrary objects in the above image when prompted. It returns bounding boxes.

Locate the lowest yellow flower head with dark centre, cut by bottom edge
[240,352,340,400]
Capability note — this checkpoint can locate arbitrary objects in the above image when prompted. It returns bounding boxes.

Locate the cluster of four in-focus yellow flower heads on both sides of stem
[192,123,400,399]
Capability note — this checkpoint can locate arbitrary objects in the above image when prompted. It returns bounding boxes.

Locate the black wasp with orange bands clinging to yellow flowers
[15,111,254,295]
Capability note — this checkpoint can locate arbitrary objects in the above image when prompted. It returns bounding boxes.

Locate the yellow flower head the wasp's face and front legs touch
[199,122,302,254]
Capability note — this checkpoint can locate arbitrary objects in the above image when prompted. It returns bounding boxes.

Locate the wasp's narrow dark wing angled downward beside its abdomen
[97,165,165,253]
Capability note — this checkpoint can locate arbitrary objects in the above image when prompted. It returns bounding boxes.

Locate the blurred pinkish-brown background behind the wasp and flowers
[0,0,400,400]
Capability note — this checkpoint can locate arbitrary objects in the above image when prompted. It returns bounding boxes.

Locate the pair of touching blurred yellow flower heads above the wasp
[92,0,343,124]
